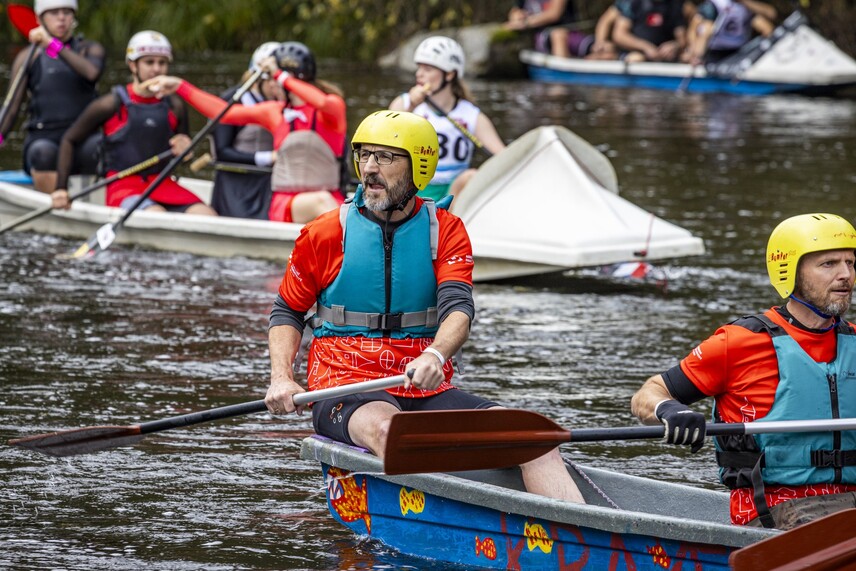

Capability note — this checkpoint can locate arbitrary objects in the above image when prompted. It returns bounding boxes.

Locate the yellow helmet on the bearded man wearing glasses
[351,111,440,190]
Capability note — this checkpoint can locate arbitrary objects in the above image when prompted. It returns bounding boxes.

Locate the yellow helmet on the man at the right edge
[767,213,856,298]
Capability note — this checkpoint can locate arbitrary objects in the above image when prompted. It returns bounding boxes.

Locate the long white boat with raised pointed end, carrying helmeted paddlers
[0,127,704,281]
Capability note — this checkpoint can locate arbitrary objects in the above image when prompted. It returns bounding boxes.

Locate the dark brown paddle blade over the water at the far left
[9,426,144,456]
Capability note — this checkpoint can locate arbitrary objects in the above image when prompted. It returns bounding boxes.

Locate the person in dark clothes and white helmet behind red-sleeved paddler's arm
[211,42,285,220]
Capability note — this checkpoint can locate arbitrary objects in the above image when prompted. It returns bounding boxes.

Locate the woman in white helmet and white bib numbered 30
[389,36,505,200]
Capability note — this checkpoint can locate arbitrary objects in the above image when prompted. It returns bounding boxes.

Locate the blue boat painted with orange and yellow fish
[301,436,778,571]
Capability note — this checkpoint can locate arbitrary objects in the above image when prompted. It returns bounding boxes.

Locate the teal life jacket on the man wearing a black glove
[714,315,856,521]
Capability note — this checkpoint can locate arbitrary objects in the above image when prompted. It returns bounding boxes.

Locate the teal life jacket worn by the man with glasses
[310,185,451,339]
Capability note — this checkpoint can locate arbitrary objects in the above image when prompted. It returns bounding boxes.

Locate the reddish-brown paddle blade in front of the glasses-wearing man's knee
[383,408,571,474]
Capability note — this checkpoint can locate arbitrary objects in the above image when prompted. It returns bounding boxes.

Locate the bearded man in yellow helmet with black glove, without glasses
[631,214,856,529]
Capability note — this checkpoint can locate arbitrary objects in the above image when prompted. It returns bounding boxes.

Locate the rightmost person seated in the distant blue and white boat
[684,0,777,65]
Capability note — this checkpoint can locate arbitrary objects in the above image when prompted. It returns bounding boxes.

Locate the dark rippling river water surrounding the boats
[0,51,856,571]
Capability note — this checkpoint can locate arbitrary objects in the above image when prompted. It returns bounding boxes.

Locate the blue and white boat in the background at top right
[520,12,856,95]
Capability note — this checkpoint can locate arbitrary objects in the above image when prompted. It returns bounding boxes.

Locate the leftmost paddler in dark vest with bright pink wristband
[0,0,104,196]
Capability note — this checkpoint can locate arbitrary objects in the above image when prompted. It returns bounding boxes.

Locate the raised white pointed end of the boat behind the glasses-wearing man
[452,126,705,279]
